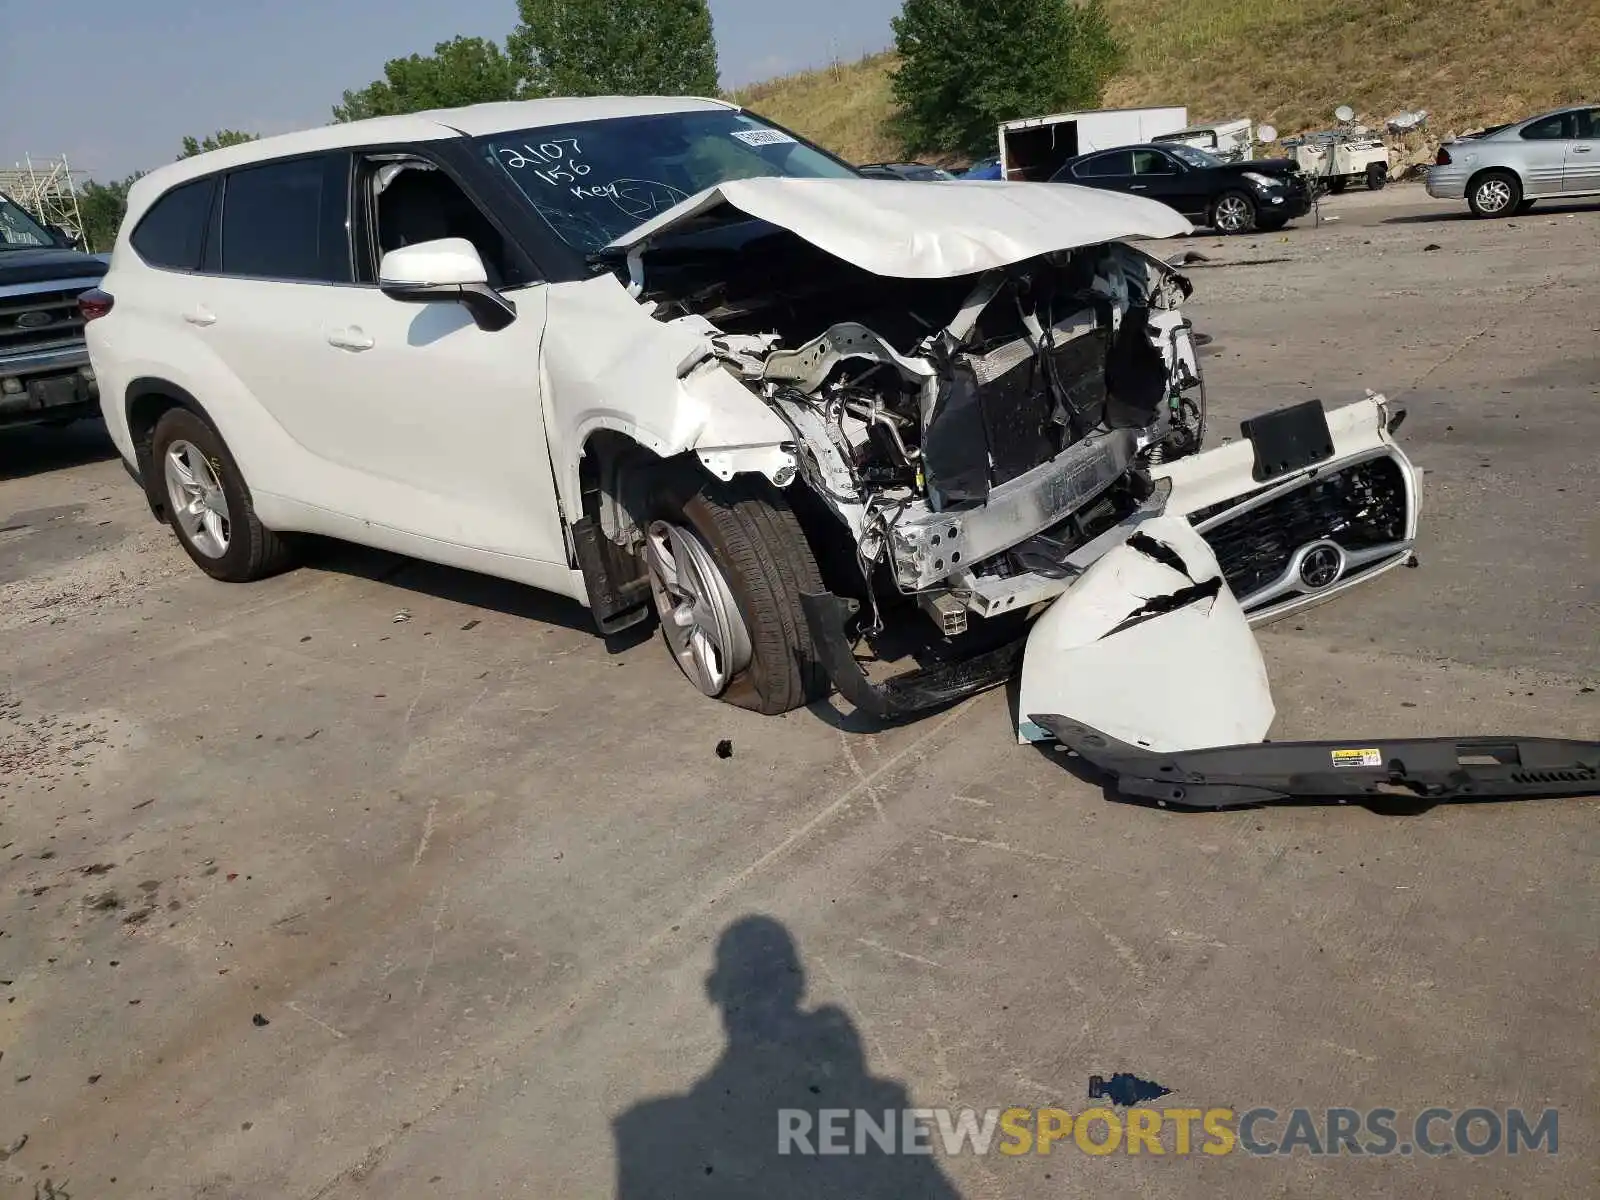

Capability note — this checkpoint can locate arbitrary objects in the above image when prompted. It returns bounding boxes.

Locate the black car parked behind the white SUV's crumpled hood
[1050,144,1312,234]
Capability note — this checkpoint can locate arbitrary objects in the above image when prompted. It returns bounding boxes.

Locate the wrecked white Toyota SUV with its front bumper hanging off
[85,98,1416,715]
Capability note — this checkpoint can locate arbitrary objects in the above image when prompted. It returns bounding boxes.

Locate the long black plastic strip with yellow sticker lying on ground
[1029,714,1600,808]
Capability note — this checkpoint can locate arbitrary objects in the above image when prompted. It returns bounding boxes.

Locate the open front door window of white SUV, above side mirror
[360,158,528,288]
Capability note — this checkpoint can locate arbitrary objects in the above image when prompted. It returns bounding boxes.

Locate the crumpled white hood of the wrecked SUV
[608,176,1192,278]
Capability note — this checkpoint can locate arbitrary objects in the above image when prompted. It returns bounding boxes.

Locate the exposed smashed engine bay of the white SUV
[634,222,1205,634]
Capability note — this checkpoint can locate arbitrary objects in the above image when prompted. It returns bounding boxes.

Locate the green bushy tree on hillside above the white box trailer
[893,0,1122,155]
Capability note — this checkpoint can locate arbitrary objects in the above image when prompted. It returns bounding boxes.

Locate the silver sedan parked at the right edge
[1427,104,1600,216]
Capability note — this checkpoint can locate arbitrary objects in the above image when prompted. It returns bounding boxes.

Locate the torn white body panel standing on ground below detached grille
[1018,517,1275,752]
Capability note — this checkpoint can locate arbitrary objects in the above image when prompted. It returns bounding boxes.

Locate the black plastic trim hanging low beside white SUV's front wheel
[800,592,1027,720]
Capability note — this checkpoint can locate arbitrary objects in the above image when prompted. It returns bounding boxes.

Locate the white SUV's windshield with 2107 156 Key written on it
[478,109,858,251]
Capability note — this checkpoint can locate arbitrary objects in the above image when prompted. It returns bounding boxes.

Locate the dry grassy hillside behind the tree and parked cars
[738,0,1600,162]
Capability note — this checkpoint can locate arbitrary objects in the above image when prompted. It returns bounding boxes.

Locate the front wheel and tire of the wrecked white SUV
[645,470,829,717]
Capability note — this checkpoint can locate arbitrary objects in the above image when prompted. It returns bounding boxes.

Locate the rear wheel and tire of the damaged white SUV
[150,408,290,584]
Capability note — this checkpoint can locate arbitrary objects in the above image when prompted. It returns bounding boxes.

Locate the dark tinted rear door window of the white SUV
[221,154,350,283]
